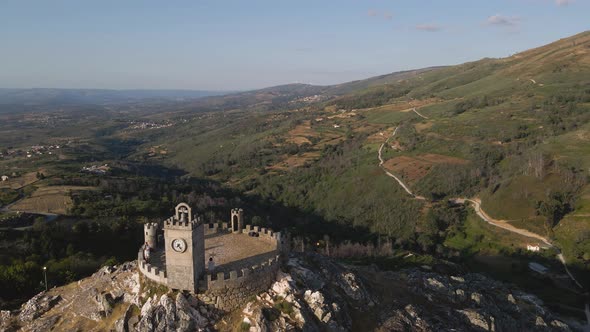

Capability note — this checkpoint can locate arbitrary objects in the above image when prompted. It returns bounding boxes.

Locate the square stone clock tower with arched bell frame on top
[164,203,205,292]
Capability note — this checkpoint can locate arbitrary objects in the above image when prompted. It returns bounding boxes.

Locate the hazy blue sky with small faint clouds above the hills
[0,0,590,90]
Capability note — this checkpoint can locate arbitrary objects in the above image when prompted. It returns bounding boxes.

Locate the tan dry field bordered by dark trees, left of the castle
[10,186,95,214]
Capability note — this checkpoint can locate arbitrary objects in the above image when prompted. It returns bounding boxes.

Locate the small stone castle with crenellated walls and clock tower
[138,203,283,310]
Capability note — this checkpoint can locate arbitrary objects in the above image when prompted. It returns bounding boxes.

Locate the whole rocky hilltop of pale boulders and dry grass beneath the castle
[0,254,581,331]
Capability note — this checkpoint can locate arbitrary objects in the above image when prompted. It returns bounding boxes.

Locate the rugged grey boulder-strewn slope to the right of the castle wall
[237,254,584,331]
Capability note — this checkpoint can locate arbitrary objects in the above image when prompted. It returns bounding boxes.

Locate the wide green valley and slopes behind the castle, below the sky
[0,32,590,321]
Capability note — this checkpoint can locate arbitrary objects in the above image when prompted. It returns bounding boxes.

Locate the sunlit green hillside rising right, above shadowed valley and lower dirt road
[128,32,590,267]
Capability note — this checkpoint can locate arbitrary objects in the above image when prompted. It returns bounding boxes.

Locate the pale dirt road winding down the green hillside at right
[378,124,590,324]
